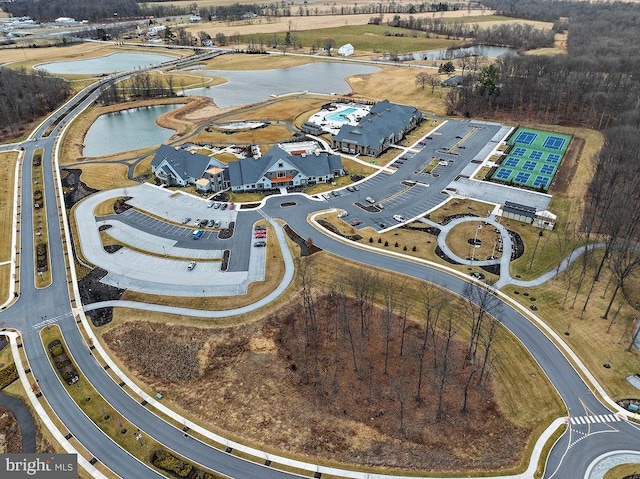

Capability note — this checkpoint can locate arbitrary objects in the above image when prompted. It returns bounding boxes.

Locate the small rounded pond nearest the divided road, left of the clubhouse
[82,104,182,157]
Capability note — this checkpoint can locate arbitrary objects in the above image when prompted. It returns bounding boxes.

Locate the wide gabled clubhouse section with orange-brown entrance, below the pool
[229,145,345,192]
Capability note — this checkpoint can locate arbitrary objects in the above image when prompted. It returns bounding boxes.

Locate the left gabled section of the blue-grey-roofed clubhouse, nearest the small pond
[151,145,228,193]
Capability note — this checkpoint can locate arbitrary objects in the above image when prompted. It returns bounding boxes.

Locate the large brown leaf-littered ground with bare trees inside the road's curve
[104,294,528,471]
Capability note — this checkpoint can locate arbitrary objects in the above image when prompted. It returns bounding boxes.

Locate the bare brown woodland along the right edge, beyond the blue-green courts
[447,0,640,336]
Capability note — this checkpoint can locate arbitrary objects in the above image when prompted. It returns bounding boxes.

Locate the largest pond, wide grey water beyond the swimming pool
[185,62,380,108]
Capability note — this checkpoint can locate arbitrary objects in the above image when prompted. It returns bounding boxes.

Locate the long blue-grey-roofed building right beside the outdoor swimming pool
[332,100,422,157]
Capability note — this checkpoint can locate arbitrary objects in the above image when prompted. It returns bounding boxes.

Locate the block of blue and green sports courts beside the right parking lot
[491,128,571,191]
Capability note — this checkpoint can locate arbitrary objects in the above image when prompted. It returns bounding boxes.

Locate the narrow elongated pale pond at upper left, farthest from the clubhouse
[34,53,175,75]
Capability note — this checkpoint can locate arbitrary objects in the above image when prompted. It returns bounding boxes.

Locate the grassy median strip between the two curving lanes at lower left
[40,325,228,479]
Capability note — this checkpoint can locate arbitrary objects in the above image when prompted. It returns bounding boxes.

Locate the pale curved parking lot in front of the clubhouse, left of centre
[76,185,266,296]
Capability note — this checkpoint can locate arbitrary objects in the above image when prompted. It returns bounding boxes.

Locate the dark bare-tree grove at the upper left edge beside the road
[0,68,71,136]
